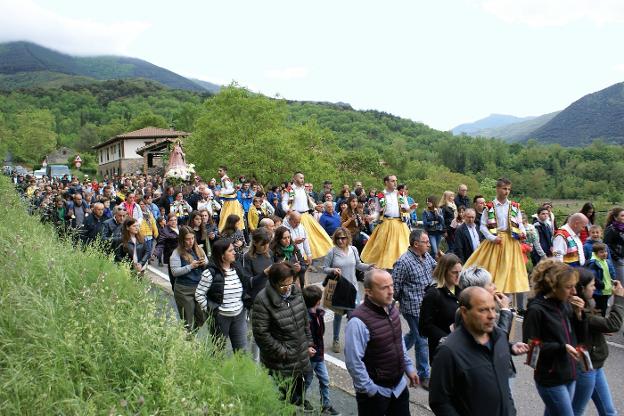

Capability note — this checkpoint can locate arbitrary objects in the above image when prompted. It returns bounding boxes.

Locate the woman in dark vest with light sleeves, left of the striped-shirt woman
[169,225,208,331]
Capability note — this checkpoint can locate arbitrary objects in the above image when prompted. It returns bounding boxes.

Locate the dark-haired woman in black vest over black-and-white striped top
[195,239,250,352]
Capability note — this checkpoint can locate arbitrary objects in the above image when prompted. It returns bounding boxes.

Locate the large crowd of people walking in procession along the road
[13,166,624,415]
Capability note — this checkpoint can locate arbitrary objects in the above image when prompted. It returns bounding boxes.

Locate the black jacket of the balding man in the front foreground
[429,326,516,416]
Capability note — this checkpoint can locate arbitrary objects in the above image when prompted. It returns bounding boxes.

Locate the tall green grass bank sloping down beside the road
[0,177,291,415]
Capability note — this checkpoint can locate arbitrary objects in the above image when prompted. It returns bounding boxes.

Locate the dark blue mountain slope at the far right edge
[529,82,624,146]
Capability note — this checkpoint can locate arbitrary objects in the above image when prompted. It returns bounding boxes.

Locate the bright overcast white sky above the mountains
[0,0,624,130]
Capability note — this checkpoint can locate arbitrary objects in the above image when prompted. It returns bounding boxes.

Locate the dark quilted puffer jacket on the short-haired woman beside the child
[251,284,313,377]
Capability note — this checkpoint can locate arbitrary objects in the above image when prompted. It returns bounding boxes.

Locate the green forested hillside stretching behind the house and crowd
[0,81,624,204]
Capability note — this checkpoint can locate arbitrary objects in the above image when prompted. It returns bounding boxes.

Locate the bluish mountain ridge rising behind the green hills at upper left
[0,42,219,92]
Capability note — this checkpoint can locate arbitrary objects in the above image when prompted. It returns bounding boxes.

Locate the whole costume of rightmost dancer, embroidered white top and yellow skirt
[464,199,529,293]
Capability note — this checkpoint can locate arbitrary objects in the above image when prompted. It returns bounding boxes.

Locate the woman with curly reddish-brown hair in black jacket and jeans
[522,259,586,416]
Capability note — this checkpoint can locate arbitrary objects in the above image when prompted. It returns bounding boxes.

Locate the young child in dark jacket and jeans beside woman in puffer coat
[303,285,340,415]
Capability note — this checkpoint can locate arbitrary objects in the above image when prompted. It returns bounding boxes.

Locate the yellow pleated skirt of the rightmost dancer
[464,232,529,293]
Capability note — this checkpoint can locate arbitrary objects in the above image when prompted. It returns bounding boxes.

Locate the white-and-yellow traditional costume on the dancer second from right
[361,190,409,269]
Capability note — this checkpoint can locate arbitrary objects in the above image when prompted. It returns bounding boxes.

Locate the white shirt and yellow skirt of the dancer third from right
[282,184,334,259]
